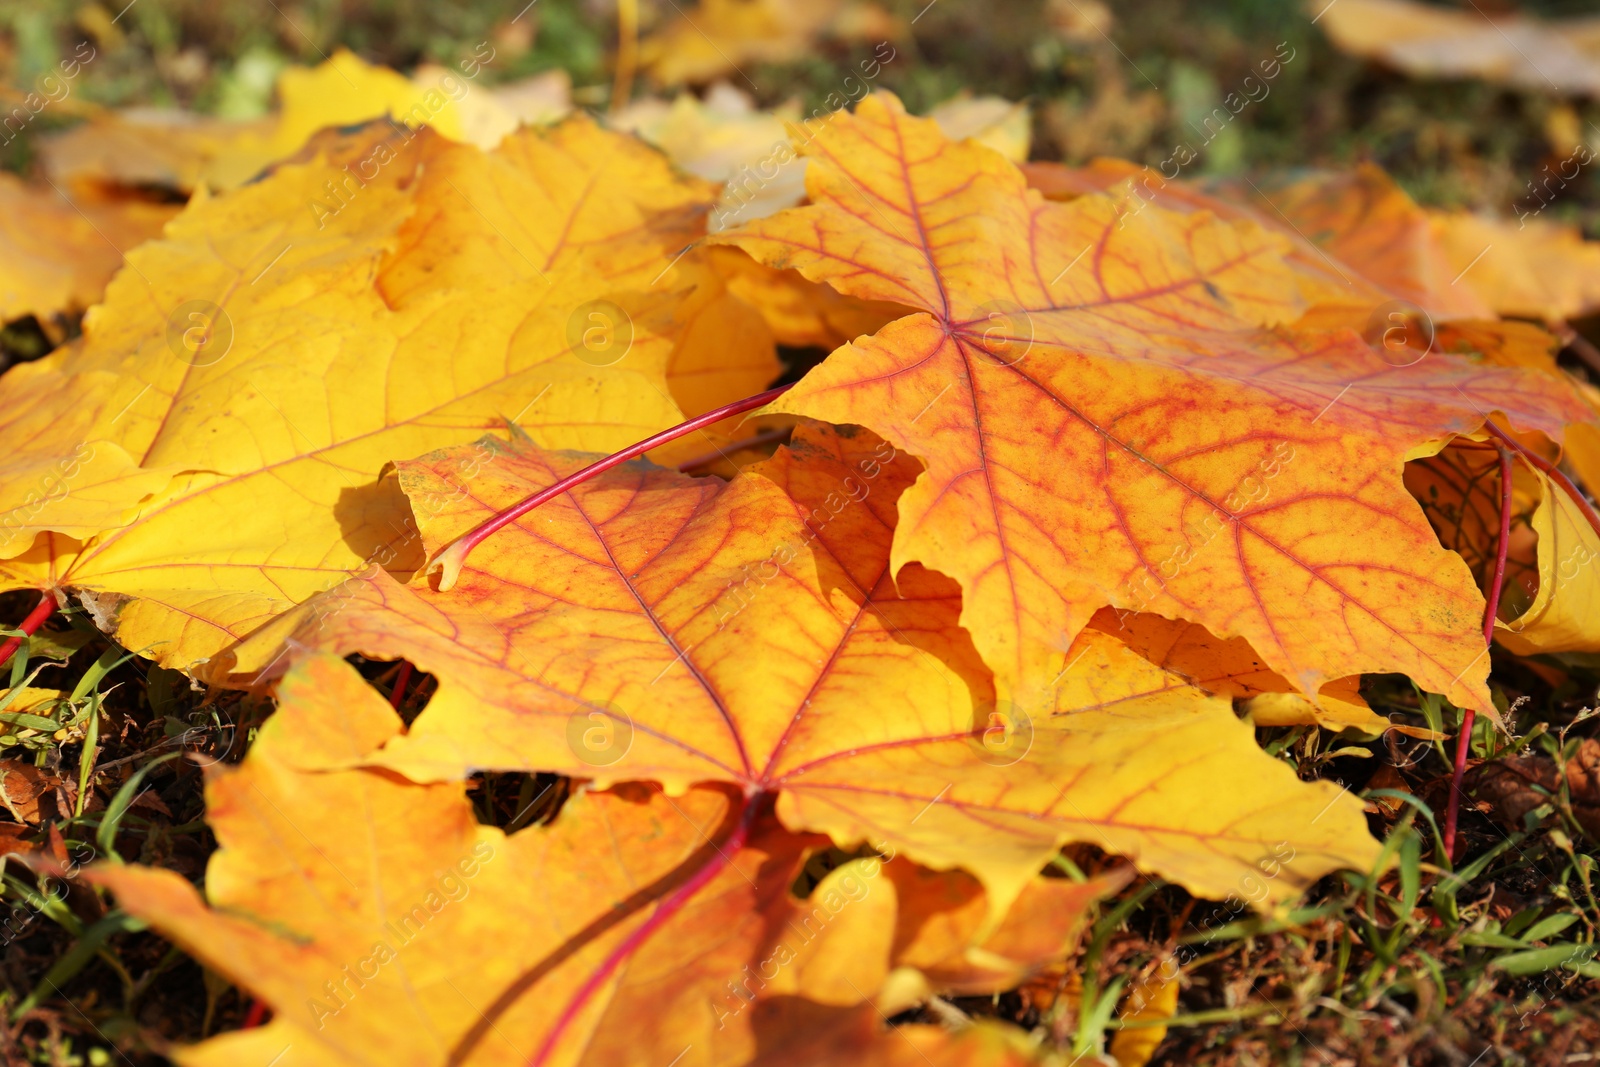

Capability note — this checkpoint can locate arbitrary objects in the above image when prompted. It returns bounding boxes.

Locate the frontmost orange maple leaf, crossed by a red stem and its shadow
[85,656,1126,1067]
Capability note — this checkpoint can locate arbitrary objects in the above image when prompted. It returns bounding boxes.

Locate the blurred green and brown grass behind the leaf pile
[0,0,1600,235]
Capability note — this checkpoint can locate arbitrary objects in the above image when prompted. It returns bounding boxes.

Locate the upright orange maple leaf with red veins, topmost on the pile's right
[710,93,1587,707]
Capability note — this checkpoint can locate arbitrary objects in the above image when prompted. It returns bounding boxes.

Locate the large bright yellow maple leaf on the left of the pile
[0,118,778,670]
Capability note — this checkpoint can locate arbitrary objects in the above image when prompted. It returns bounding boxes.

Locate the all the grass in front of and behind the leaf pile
[0,0,1600,1067]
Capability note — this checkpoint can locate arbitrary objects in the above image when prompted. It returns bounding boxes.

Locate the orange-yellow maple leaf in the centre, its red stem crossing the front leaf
[262,426,1374,907]
